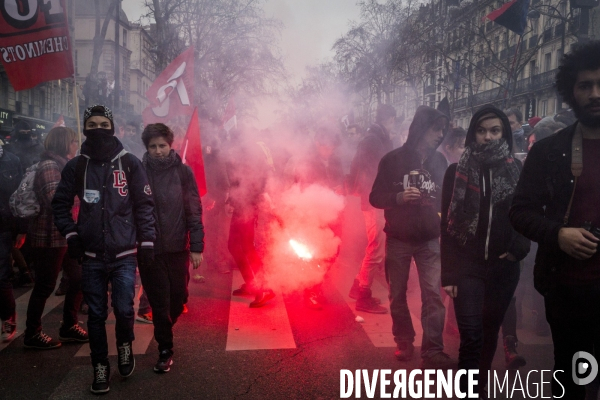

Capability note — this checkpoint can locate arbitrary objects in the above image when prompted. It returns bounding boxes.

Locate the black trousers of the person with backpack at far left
[25,247,83,337]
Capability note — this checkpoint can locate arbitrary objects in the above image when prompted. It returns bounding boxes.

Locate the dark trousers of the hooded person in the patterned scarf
[454,260,520,385]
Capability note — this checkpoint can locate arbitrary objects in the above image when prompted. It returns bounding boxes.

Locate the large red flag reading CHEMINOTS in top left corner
[0,0,74,91]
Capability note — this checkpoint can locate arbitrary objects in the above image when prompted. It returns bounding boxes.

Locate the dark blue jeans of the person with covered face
[81,256,136,365]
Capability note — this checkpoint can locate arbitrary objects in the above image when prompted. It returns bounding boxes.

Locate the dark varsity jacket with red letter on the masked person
[52,138,155,261]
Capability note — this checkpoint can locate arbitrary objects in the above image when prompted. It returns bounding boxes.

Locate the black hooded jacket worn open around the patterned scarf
[440,106,530,286]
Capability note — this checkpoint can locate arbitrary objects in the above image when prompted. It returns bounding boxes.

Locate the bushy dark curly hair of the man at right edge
[556,40,600,108]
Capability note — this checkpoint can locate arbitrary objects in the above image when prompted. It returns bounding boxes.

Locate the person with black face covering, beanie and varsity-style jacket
[52,106,155,394]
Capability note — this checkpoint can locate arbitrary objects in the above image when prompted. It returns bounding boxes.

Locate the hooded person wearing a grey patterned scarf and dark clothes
[441,106,529,396]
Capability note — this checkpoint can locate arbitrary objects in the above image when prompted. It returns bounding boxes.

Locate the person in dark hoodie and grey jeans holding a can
[369,106,456,369]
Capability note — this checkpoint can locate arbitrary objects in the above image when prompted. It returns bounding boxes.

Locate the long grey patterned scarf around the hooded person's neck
[448,138,520,245]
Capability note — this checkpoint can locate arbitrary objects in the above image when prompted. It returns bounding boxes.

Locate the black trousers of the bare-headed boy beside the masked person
[138,251,189,351]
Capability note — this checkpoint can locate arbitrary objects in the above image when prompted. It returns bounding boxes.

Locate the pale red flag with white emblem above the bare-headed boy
[142,47,194,125]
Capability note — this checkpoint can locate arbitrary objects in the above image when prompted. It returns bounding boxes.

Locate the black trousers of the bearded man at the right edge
[544,282,600,400]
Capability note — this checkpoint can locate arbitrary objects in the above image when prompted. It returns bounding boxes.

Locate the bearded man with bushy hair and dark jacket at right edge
[510,41,600,399]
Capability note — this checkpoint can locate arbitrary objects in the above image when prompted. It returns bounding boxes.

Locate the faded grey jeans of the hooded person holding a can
[385,236,446,358]
